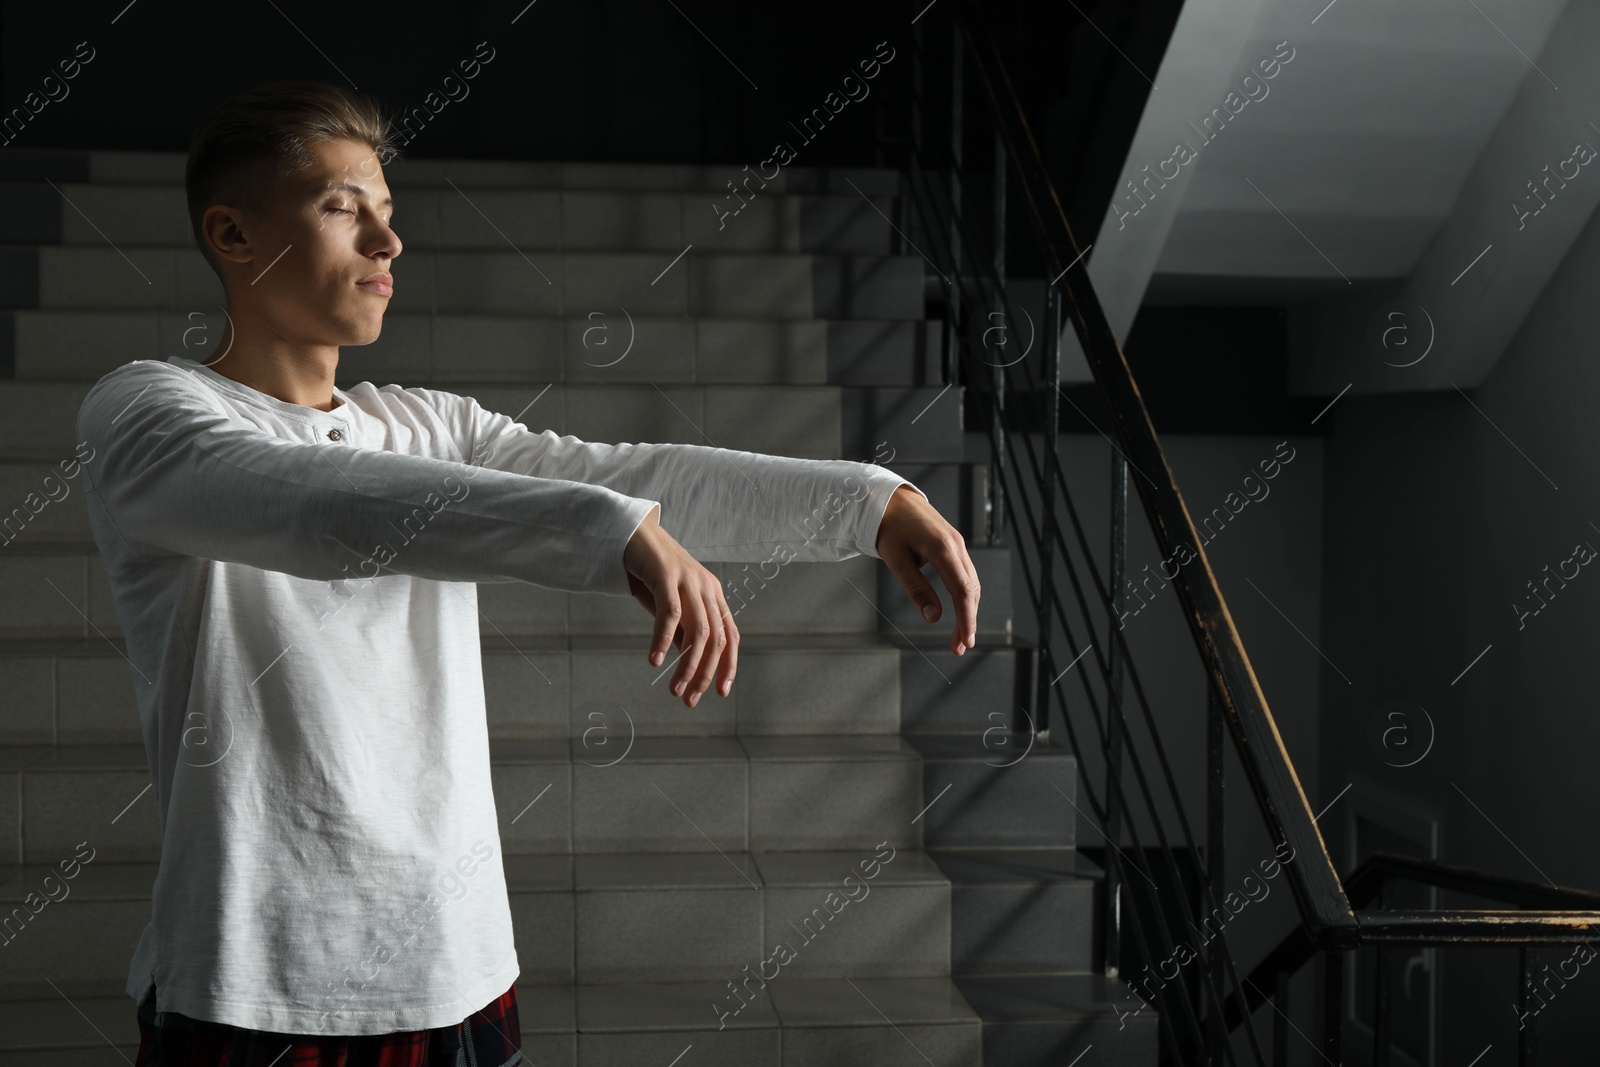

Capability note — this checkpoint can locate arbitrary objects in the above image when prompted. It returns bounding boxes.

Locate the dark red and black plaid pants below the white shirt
[136,982,523,1067]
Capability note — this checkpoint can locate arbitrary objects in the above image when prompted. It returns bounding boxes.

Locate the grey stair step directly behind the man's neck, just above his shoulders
[0,306,942,385]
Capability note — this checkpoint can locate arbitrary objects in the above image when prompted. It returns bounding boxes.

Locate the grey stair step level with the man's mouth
[0,245,926,320]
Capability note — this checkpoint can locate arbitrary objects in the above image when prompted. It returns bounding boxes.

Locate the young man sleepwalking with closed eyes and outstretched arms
[78,82,979,1067]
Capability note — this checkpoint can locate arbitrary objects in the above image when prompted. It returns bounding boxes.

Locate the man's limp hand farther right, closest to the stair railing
[875,485,982,656]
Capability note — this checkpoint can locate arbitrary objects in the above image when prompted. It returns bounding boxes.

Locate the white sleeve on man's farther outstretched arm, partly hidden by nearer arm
[434,385,928,563]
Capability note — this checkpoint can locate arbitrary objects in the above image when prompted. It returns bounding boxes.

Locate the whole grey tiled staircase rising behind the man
[0,150,1157,1067]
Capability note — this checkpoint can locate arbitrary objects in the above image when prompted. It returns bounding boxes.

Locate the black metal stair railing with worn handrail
[880,0,1600,1064]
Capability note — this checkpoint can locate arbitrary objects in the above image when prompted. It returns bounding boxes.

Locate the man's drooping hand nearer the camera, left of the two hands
[622,507,739,707]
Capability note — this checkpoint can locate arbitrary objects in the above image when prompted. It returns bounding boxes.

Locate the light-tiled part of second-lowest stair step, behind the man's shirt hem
[0,846,950,997]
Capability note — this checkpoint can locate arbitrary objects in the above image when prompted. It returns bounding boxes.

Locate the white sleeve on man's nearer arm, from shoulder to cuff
[77,360,659,595]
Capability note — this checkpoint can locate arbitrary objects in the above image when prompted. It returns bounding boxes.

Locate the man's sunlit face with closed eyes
[230,141,402,346]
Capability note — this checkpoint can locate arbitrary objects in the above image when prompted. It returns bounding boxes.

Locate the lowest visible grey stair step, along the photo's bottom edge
[0,971,1160,1067]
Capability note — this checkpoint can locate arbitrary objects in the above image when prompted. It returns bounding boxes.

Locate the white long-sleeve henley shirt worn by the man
[78,357,920,1035]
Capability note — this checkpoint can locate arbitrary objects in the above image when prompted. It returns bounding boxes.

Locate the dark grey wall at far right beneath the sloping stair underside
[1320,154,1600,1064]
